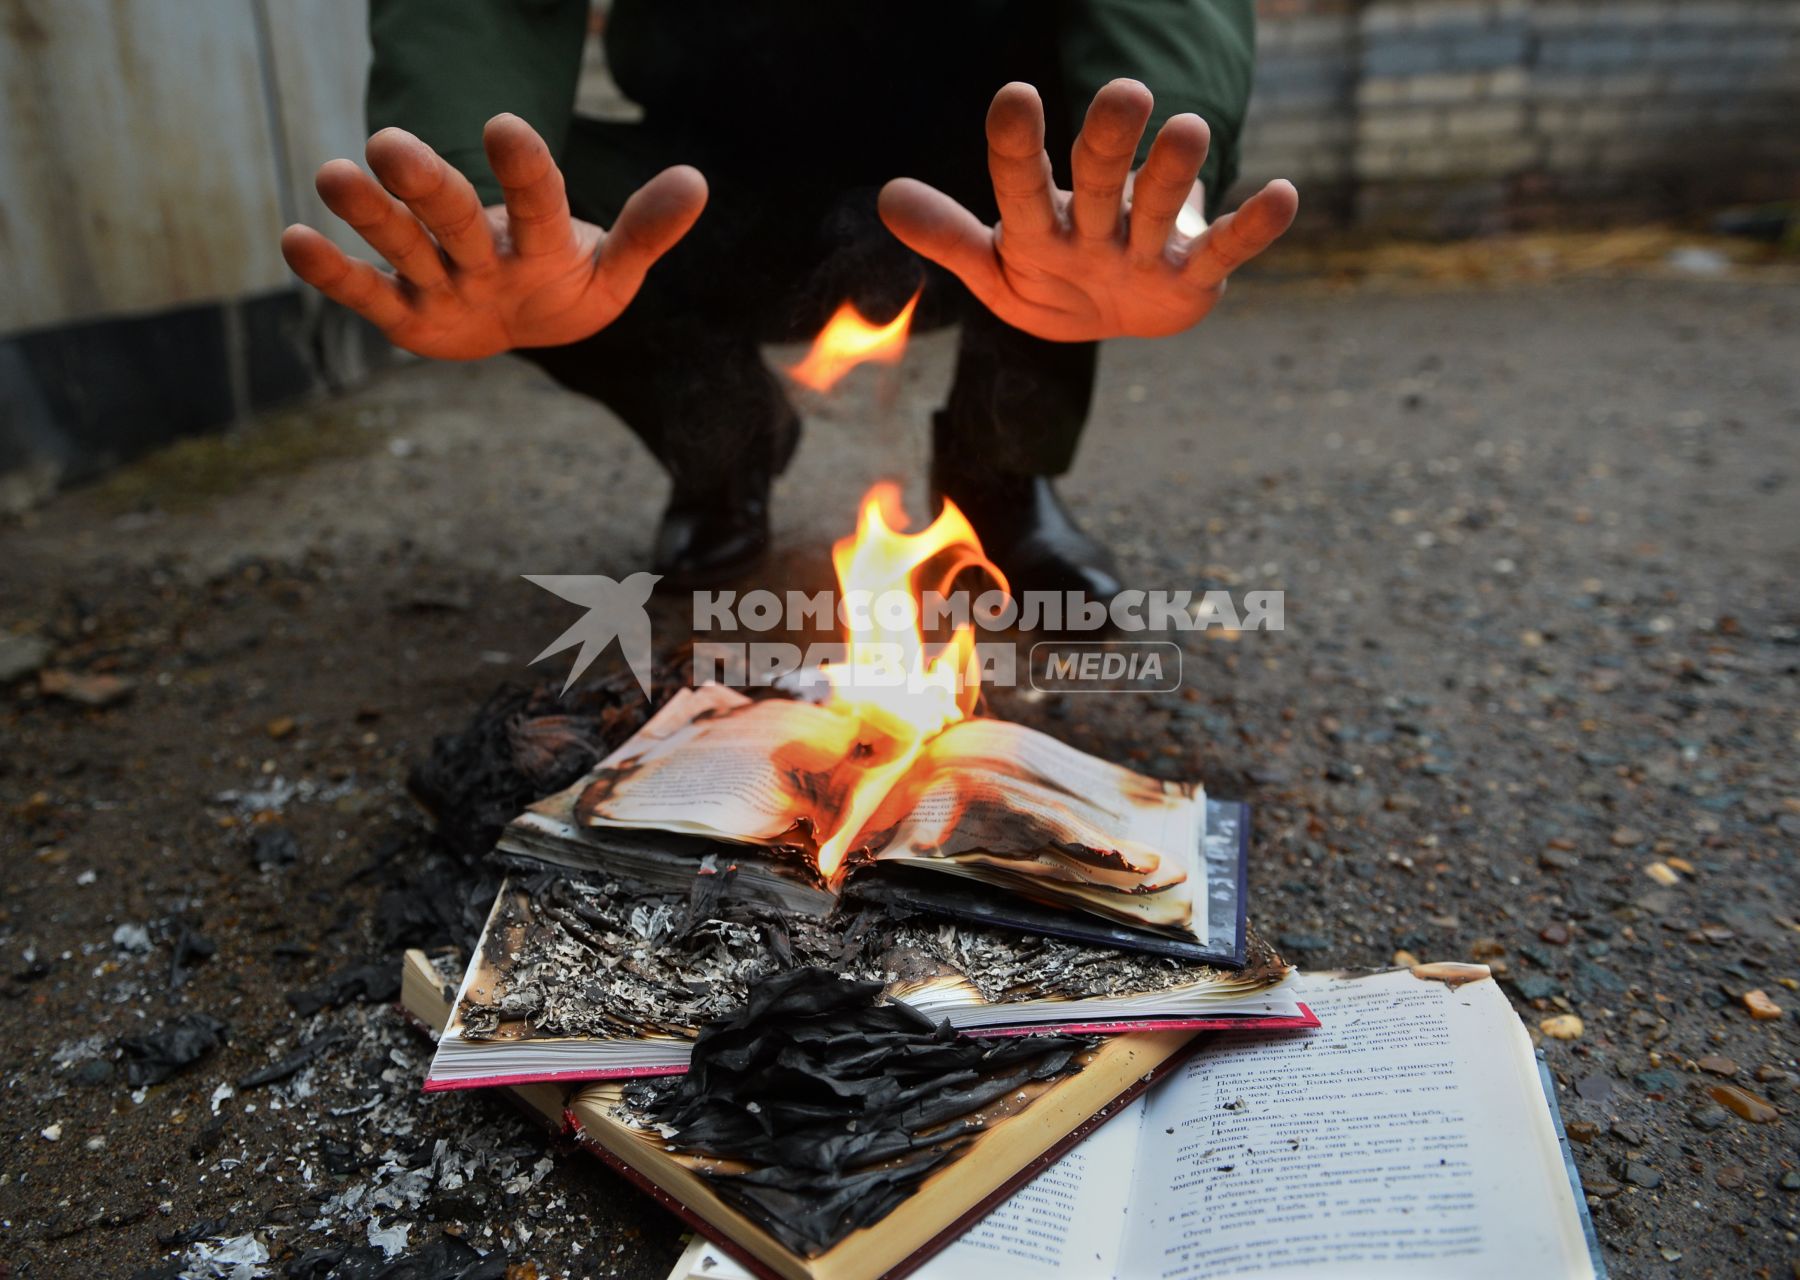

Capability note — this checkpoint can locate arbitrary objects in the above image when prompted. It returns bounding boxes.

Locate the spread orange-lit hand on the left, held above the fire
[281,115,706,360]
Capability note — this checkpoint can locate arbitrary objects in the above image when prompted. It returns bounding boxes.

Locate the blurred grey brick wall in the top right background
[1244,0,1800,234]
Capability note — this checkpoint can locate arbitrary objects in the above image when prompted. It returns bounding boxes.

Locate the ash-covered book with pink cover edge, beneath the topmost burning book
[425,873,1318,1089]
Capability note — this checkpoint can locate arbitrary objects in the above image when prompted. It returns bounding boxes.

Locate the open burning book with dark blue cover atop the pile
[500,684,1244,963]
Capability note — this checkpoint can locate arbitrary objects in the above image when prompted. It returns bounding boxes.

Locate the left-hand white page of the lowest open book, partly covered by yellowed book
[670,1098,1145,1280]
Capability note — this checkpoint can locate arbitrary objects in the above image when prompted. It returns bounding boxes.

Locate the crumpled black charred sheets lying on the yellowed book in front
[625,967,1094,1257]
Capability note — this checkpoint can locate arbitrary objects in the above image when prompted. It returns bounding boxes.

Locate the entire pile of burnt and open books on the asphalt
[403,686,1600,1280]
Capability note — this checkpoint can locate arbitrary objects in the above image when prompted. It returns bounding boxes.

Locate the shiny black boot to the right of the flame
[931,421,1123,605]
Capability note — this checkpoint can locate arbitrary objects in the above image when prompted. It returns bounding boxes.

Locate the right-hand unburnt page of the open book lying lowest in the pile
[1118,970,1593,1280]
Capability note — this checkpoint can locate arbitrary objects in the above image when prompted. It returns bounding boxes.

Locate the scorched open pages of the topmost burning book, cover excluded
[576,686,1208,942]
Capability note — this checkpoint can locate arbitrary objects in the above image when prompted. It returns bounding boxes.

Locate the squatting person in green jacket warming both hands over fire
[283,0,1296,598]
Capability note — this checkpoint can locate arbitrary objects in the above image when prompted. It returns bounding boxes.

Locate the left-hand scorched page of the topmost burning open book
[576,684,877,856]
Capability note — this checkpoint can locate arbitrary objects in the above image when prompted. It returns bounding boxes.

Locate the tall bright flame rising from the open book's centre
[819,484,1006,882]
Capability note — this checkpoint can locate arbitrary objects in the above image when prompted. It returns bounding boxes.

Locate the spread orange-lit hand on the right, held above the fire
[880,79,1300,342]
